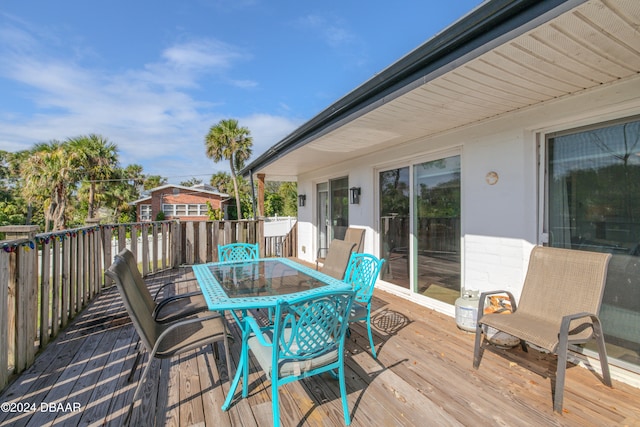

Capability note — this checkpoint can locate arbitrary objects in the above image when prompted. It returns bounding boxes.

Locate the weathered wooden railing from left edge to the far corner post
[0,220,265,390]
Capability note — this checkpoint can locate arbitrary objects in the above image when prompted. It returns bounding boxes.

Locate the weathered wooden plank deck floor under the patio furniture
[0,271,640,427]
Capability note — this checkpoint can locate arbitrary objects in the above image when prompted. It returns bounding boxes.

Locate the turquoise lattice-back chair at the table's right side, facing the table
[344,253,384,359]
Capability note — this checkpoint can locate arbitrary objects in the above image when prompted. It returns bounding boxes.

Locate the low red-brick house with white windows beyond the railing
[132,184,229,221]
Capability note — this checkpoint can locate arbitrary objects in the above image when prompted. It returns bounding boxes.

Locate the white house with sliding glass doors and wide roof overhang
[242,0,640,384]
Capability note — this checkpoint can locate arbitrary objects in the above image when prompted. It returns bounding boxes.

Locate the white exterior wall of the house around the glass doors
[298,73,640,315]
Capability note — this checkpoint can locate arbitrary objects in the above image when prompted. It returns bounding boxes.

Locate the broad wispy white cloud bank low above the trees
[0,20,292,182]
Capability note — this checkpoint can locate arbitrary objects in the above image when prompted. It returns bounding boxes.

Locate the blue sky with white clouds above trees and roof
[0,0,481,183]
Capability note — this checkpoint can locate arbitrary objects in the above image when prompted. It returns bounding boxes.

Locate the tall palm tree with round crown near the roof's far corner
[204,119,253,219]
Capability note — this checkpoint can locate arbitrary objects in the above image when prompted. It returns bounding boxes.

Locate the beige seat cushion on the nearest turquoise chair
[248,328,338,378]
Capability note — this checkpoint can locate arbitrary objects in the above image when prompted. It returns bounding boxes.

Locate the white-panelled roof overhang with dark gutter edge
[242,0,640,180]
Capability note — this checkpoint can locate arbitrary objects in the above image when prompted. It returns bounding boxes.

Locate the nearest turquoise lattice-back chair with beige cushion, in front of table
[222,290,354,426]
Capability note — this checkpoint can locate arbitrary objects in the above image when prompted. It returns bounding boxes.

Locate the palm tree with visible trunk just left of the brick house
[67,134,118,218]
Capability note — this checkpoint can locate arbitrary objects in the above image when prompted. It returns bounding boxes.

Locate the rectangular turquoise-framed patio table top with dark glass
[193,258,351,316]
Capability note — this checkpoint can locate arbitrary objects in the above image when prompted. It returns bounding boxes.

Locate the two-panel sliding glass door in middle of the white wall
[379,156,461,304]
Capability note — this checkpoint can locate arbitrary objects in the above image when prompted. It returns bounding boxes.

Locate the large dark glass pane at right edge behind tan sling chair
[544,118,640,370]
